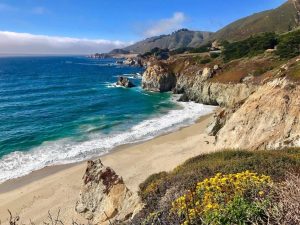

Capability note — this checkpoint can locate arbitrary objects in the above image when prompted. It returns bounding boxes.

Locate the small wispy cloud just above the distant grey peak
[144,12,186,37]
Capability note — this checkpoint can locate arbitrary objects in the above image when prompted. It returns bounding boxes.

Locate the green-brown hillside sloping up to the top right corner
[212,0,300,41]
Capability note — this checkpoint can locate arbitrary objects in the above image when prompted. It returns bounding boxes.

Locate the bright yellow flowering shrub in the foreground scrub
[172,171,272,225]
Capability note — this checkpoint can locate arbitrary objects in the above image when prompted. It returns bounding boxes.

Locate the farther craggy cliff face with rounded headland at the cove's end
[142,61,258,106]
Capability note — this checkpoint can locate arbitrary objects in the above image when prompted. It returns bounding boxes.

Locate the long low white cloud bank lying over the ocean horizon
[0,31,131,54]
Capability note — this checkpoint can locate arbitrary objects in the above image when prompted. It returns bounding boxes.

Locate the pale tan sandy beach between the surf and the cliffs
[0,115,214,224]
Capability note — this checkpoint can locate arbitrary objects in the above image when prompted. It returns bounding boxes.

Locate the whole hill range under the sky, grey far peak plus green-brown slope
[113,0,300,53]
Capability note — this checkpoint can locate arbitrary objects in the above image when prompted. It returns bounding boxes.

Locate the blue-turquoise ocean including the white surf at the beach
[0,56,213,182]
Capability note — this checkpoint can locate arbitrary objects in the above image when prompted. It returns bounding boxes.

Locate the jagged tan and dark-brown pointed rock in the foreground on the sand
[76,159,142,225]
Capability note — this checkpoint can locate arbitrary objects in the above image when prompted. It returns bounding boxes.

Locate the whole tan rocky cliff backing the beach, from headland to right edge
[143,54,300,150]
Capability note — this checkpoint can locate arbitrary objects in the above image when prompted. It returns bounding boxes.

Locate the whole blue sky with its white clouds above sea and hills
[0,0,285,54]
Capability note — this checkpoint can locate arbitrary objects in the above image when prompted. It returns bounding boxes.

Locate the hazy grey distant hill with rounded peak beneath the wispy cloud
[124,29,213,53]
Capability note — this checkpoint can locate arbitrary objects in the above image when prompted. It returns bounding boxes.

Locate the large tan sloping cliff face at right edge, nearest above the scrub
[216,78,300,150]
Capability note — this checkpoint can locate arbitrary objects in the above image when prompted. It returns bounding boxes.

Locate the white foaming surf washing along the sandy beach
[0,102,214,182]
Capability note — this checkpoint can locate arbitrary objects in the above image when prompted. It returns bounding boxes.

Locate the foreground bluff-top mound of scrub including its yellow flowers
[133,149,300,224]
